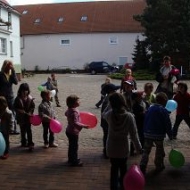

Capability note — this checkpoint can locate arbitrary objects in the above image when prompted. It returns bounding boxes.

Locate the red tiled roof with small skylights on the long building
[13,0,146,35]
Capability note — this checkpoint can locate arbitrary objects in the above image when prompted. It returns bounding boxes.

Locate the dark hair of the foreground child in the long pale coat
[109,92,126,111]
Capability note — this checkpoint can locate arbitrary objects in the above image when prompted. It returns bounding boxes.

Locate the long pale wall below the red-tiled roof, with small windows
[21,33,140,70]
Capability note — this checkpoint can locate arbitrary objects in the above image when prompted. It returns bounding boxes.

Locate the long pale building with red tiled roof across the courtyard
[14,0,146,70]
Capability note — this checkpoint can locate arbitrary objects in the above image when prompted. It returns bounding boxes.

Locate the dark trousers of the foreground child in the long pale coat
[110,158,127,190]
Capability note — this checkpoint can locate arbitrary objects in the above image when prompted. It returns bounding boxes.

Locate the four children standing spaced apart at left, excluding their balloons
[0,73,89,166]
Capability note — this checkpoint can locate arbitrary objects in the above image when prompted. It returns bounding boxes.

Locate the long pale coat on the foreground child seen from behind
[102,110,141,158]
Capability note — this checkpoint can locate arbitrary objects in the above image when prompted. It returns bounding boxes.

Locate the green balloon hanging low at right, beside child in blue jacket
[169,149,185,168]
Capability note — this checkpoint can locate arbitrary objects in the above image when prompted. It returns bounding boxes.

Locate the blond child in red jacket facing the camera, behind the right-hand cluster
[120,69,137,93]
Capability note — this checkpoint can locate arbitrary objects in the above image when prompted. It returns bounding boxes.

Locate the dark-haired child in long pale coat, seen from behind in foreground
[102,92,142,190]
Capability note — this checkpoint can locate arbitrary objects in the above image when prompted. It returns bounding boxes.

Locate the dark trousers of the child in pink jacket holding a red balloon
[66,131,79,164]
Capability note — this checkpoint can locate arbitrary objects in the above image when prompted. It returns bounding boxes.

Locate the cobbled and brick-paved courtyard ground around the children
[0,74,190,190]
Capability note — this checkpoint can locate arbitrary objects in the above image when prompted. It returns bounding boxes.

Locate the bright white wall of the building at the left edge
[0,7,21,73]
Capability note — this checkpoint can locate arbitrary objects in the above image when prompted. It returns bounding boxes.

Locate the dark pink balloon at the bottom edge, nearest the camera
[123,165,145,190]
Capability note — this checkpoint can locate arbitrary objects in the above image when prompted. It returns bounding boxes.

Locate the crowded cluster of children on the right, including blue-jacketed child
[100,69,190,190]
